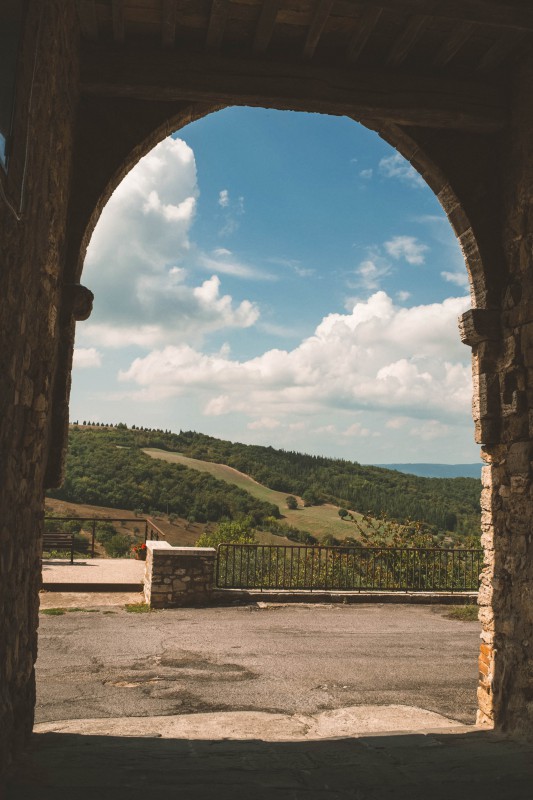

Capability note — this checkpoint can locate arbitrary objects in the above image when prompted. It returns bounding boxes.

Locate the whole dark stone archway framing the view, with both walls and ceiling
[0,0,533,776]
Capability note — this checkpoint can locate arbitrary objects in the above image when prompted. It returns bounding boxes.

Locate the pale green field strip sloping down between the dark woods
[143,448,361,539]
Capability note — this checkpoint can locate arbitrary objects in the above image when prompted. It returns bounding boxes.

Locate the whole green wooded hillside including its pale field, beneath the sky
[55,424,481,545]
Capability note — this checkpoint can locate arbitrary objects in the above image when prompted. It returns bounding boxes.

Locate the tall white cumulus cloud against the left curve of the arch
[79,138,259,348]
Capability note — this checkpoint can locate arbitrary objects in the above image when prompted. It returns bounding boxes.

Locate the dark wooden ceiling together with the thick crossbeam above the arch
[76,0,533,131]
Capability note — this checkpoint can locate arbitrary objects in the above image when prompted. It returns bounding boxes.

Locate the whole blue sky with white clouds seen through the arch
[71,108,478,463]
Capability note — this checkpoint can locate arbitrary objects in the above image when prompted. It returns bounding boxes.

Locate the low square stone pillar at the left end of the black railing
[144,541,216,608]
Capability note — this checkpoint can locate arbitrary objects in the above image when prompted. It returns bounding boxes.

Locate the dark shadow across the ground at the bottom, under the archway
[2,730,533,800]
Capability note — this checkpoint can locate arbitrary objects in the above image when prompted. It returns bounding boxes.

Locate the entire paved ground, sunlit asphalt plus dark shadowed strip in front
[5,593,533,800]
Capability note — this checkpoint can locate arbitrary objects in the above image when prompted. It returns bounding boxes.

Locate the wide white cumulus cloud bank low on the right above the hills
[119,291,471,428]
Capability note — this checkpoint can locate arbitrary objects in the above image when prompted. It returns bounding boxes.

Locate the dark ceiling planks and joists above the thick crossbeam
[77,0,533,75]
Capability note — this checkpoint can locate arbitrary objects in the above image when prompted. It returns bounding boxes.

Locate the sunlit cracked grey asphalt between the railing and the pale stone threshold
[36,595,479,724]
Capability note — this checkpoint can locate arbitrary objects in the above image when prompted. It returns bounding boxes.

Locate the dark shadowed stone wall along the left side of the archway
[0,0,77,772]
